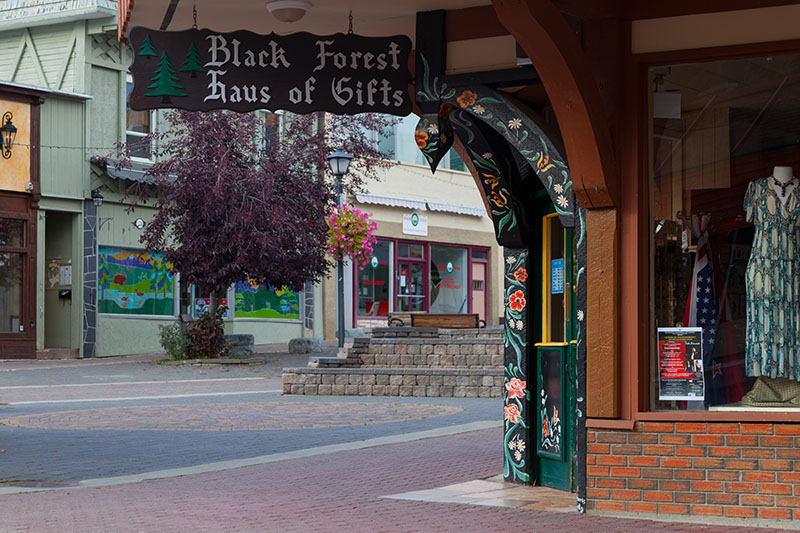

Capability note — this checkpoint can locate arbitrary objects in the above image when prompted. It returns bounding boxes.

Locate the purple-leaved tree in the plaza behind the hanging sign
[122,110,392,355]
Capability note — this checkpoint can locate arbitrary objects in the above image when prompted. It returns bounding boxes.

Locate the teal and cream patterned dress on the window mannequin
[744,178,800,381]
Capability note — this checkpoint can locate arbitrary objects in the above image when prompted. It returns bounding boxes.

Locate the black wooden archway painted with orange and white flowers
[415,54,586,510]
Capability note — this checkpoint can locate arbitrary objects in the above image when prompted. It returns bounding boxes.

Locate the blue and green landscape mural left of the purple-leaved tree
[97,246,175,316]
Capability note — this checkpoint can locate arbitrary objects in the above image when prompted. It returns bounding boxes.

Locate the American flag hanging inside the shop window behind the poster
[683,215,725,405]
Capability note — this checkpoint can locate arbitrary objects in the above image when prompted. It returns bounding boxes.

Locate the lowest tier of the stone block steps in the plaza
[282,368,504,398]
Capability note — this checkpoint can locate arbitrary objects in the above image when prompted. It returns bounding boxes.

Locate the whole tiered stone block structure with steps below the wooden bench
[283,327,503,398]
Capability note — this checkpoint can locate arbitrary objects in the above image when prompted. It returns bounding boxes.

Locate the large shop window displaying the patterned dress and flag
[649,55,800,410]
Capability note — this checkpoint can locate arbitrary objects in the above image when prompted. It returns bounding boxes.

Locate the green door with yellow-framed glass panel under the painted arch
[531,197,576,490]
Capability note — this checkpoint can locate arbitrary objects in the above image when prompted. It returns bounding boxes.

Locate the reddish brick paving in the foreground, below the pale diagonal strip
[0,430,788,533]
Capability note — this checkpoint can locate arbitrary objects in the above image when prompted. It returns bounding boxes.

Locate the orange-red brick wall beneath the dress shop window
[586,422,800,520]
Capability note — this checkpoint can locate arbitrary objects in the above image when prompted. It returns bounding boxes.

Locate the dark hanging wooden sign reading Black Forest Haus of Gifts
[128,26,411,116]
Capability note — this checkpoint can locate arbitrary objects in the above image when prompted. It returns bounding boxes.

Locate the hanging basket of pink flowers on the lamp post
[325,205,378,268]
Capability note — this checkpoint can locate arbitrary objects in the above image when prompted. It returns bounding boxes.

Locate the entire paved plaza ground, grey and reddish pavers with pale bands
[0,354,792,533]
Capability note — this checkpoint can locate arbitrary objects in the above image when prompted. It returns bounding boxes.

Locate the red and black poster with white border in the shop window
[658,328,705,401]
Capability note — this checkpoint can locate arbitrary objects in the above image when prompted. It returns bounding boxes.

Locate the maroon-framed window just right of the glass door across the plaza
[430,245,468,313]
